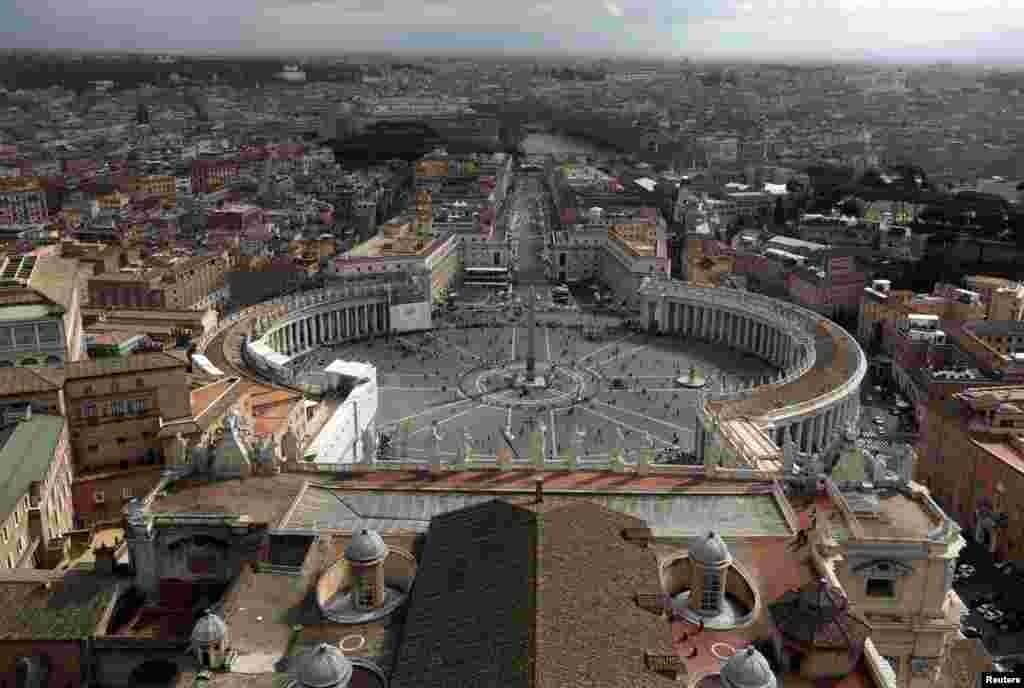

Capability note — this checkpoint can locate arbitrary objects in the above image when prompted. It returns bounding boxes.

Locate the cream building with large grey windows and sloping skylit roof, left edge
[0,255,85,368]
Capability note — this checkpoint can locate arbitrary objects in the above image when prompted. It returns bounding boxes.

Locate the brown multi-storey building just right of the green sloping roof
[65,352,191,521]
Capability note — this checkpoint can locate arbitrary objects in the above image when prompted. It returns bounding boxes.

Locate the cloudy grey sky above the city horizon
[6,0,1024,62]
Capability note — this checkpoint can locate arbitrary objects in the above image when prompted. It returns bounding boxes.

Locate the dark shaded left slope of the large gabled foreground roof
[391,501,537,688]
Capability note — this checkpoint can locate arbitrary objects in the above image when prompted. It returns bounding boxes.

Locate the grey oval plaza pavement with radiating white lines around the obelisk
[300,323,772,460]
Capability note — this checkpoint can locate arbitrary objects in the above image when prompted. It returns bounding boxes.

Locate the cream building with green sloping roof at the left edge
[0,406,74,568]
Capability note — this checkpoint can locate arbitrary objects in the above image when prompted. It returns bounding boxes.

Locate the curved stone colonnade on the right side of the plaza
[641,280,867,456]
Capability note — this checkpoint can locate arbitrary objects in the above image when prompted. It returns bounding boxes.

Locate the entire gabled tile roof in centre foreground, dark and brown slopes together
[392,501,674,688]
